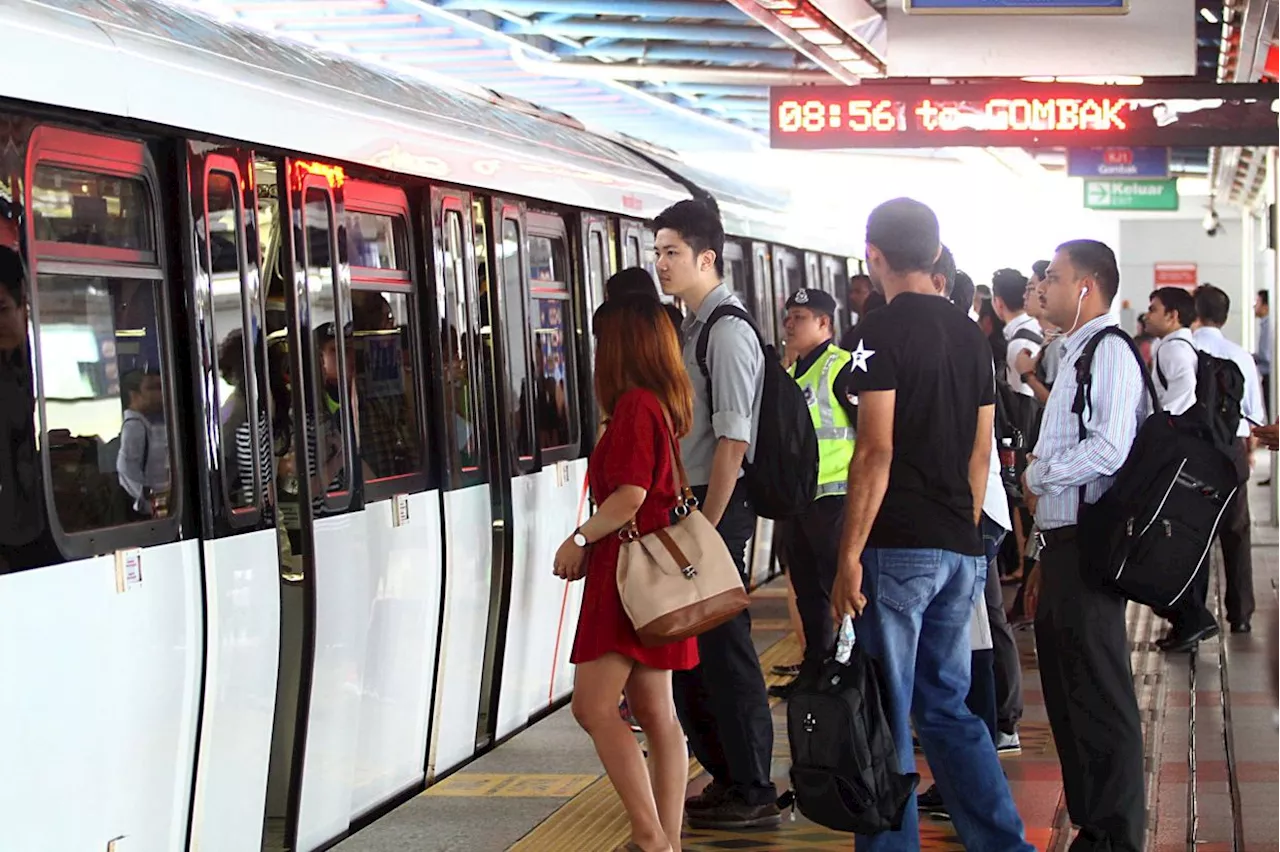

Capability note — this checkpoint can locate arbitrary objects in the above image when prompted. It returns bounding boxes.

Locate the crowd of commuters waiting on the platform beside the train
[556,198,1280,852]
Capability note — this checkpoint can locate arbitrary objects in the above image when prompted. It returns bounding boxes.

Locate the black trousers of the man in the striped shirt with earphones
[1036,533,1147,852]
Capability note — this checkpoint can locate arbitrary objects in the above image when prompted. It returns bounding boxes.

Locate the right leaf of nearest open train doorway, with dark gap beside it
[255,159,369,849]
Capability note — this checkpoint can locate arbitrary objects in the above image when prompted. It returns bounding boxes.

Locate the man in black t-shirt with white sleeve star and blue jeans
[832,198,1033,852]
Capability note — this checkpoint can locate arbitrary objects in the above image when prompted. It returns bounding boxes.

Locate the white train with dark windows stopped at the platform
[0,0,861,852]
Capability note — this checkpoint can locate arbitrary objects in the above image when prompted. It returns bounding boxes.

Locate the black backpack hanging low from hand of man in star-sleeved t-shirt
[778,629,920,834]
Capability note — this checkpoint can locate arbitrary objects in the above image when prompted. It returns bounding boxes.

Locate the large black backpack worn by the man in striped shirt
[1071,326,1248,610]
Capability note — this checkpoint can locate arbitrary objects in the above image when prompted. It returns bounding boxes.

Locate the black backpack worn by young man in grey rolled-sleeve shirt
[696,304,818,521]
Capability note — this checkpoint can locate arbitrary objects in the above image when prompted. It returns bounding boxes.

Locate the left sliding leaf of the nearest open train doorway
[187,143,282,849]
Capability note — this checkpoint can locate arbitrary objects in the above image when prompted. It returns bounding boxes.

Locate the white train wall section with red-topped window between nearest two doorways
[343,180,444,819]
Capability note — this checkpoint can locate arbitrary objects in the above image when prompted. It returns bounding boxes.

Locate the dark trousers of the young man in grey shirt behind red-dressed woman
[672,484,778,805]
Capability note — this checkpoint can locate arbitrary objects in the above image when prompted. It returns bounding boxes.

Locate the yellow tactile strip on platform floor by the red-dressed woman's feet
[511,633,800,852]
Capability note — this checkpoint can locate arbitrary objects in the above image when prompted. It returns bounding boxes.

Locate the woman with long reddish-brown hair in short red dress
[556,297,698,852]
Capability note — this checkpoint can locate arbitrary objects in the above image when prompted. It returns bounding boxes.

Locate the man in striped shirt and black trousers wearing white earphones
[1024,239,1151,852]
